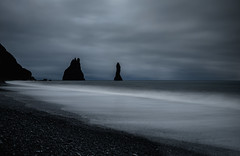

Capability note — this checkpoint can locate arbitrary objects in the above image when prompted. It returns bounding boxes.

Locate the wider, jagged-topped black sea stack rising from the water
[63,58,85,80]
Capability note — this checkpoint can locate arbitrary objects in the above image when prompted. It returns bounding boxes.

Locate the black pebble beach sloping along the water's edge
[0,90,239,155]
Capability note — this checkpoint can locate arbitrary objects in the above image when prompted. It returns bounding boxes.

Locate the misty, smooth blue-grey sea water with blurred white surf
[3,81,240,151]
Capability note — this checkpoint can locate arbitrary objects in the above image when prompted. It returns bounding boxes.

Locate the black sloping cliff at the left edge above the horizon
[0,44,35,81]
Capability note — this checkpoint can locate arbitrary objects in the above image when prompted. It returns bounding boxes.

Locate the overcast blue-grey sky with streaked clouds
[0,0,240,80]
